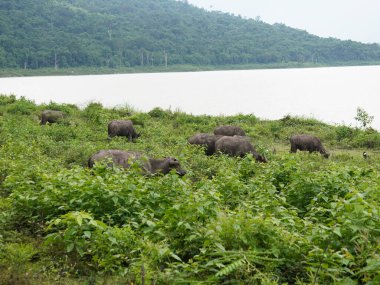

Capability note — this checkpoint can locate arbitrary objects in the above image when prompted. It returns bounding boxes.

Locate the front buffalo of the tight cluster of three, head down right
[215,136,267,162]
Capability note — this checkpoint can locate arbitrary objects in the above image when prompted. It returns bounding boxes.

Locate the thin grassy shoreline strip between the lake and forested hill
[0,61,380,78]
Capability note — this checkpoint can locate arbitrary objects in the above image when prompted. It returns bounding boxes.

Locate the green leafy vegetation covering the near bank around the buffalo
[0,96,380,285]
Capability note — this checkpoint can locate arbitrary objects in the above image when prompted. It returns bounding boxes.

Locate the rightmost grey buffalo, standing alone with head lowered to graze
[290,135,330,158]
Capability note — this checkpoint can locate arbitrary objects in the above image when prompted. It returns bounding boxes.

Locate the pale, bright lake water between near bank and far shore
[0,66,380,130]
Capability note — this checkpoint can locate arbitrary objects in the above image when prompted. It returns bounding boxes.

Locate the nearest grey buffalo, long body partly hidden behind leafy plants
[88,149,186,176]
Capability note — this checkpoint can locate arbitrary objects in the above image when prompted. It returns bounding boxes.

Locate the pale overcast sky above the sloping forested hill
[188,0,380,43]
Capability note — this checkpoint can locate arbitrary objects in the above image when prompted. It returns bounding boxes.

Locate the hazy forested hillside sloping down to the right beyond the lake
[0,0,380,68]
